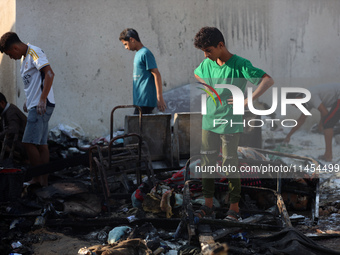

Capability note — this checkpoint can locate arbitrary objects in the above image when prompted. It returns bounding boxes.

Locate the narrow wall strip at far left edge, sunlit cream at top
[0,0,16,103]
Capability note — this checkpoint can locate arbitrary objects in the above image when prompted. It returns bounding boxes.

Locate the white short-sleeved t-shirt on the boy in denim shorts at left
[20,44,55,110]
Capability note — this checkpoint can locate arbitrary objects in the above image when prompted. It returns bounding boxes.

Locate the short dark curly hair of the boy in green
[194,27,225,50]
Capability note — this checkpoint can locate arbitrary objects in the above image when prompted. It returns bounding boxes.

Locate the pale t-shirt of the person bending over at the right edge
[307,83,340,109]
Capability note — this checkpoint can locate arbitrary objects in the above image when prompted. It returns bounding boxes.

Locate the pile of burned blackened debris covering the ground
[0,116,340,255]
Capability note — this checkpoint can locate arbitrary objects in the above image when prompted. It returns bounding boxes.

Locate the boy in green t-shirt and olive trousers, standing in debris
[194,27,274,220]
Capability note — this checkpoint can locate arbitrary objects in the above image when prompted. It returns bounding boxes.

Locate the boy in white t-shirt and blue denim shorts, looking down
[0,32,55,186]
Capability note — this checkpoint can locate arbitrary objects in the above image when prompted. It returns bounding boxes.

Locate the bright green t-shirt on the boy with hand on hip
[195,55,265,134]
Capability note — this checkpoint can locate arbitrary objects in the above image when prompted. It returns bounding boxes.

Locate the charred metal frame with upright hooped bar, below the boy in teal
[89,105,155,207]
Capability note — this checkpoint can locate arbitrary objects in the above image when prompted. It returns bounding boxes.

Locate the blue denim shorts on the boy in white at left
[22,106,54,145]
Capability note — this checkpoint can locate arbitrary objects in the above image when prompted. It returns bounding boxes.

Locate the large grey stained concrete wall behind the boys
[0,0,340,136]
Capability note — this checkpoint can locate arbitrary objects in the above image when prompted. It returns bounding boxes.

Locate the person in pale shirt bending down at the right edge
[284,83,340,162]
